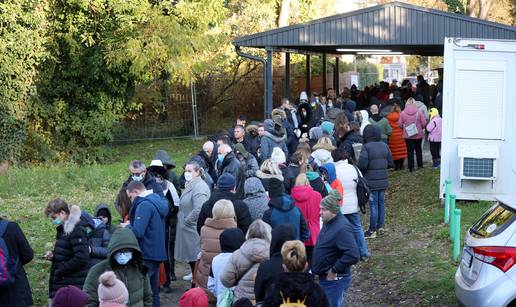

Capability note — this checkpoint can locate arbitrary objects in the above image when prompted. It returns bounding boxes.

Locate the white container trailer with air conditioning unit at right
[439,38,516,200]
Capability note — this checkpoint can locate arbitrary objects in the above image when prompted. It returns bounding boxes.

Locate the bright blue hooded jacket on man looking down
[127,193,168,261]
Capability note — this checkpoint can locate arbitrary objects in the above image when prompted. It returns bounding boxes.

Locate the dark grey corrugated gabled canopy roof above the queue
[233,2,516,56]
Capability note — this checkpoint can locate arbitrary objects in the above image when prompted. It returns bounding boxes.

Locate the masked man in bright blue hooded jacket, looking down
[121,181,169,307]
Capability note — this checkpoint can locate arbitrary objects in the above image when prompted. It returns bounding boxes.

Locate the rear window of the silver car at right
[470,203,516,238]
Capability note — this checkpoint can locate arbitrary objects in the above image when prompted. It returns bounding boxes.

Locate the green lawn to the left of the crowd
[0,139,201,306]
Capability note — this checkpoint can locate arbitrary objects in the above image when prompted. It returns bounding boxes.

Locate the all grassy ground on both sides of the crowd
[0,139,496,306]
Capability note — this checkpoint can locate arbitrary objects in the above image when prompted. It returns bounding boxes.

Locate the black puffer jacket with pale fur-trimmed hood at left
[48,205,90,298]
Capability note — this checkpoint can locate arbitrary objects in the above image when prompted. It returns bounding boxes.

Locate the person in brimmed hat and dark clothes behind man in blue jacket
[149,160,179,293]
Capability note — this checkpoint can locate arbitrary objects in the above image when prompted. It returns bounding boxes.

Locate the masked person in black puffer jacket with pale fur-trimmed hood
[43,198,90,301]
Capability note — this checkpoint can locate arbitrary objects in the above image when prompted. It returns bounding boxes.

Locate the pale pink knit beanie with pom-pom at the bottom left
[98,271,129,307]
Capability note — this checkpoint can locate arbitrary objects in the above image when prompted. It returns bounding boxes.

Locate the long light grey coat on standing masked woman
[174,177,210,261]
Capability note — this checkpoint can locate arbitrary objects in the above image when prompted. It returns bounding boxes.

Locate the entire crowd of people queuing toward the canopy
[0,76,442,307]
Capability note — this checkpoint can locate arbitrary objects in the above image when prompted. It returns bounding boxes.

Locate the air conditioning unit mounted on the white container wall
[458,144,500,181]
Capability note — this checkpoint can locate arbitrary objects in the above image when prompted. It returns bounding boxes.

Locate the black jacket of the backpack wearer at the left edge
[0,218,34,307]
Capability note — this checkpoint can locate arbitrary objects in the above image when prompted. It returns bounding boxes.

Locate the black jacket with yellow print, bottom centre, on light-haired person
[262,272,330,307]
